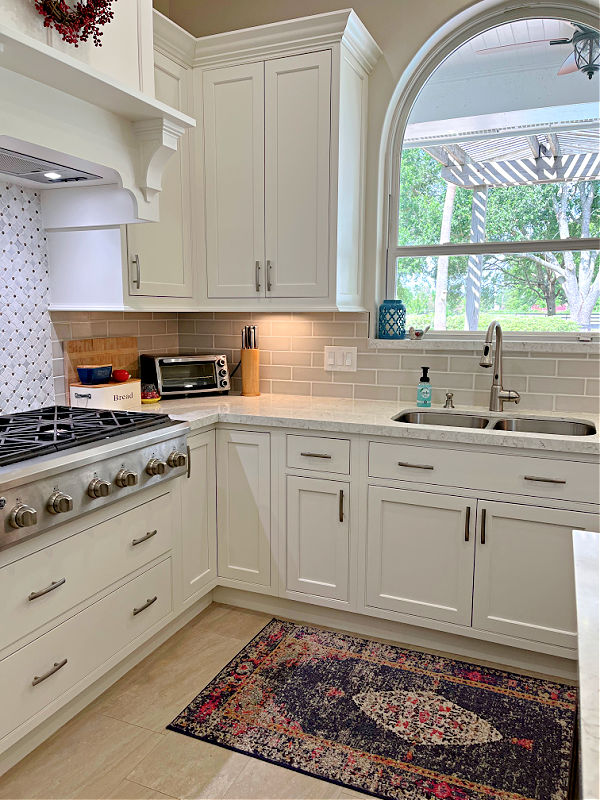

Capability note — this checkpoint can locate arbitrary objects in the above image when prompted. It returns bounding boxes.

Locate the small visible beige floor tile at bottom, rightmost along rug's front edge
[224,758,341,800]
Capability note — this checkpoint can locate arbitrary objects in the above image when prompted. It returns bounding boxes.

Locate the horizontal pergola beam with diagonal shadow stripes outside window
[441,153,600,189]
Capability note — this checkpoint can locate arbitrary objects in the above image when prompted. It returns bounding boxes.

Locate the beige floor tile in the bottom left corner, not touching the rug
[0,711,162,800]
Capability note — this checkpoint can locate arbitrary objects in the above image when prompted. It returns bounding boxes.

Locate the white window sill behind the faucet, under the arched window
[369,331,600,356]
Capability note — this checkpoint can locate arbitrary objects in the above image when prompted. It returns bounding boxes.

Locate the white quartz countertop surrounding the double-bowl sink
[136,394,600,456]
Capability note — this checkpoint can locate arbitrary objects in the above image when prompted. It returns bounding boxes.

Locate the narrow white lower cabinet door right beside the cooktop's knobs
[181,431,217,602]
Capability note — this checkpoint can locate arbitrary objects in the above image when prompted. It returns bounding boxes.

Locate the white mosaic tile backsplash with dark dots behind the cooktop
[0,183,54,414]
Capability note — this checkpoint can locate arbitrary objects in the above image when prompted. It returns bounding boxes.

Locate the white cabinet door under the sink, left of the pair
[366,486,477,625]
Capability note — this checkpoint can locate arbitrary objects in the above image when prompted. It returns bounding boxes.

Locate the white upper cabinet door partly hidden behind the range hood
[127,53,193,297]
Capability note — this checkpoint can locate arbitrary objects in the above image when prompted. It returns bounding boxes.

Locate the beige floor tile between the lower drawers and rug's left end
[94,631,242,732]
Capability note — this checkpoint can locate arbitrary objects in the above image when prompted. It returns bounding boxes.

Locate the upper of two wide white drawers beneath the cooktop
[0,494,172,650]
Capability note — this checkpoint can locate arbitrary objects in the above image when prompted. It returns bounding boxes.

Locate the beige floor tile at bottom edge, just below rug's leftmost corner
[127,731,248,798]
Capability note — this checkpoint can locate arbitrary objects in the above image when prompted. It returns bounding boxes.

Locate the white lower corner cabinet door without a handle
[217,430,271,586]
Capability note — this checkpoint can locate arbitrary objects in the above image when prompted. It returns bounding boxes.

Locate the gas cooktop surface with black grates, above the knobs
[0,406,173,466]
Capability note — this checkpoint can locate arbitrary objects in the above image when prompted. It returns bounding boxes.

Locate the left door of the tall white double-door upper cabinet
[202,63,265,298]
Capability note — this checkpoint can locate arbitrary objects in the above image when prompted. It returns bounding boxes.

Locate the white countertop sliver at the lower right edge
[573,531,600,800]
